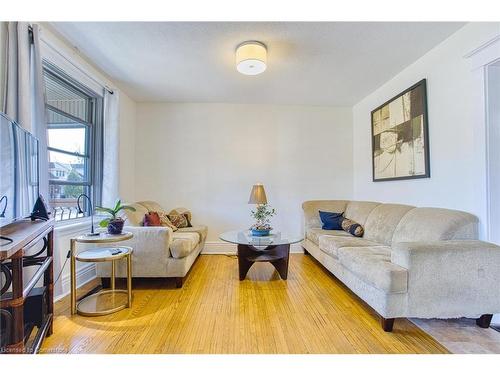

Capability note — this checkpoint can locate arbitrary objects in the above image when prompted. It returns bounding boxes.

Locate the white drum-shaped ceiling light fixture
[236,41,267,76]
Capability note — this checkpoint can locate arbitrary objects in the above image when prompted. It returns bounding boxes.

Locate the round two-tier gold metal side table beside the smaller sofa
[71,232,133,316]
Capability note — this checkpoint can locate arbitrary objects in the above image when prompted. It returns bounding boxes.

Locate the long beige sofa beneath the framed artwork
[302,200,500,331]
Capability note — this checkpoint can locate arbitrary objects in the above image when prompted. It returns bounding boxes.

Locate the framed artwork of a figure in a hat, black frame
[371,79,430,182]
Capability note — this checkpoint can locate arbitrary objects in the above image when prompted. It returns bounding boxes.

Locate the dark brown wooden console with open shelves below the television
[0,219,54,353]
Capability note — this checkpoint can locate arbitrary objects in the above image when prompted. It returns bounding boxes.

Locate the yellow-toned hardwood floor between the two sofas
[41,254,447,353]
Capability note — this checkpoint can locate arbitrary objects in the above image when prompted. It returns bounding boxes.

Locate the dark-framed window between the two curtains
[44,63,103,220]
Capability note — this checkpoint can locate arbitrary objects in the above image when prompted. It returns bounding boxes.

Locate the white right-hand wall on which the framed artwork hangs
[353,23,500,239]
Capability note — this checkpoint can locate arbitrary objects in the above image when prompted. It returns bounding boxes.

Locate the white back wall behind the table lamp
[136,103,352,242]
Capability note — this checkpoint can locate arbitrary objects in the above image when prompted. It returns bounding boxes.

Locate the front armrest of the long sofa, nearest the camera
[391,240,500,317]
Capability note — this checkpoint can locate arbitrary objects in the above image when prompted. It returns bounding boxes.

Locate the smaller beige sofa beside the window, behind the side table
[97,201,207,288]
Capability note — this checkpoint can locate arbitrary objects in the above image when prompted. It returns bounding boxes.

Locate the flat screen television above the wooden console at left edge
[0,112,39,228]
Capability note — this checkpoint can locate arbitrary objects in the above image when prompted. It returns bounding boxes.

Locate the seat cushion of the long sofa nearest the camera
[338,246,408,293]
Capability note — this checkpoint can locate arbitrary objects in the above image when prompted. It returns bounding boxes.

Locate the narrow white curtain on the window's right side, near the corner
[102,90,120,207]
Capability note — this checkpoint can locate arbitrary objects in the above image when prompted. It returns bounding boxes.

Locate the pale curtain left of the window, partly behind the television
[3,22,49,212]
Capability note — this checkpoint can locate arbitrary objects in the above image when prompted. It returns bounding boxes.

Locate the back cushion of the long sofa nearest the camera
[364,203,415,246]
